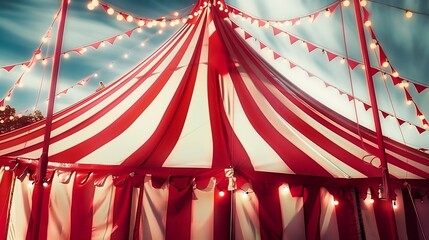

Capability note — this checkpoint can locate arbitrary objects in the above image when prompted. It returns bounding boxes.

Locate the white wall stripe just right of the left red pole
[47,174,75,239]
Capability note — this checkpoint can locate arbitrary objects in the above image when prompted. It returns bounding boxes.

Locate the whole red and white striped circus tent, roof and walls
[0,0,429,239]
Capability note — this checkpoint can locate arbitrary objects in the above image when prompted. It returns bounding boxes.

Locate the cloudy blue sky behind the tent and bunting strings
[0,0,429,147]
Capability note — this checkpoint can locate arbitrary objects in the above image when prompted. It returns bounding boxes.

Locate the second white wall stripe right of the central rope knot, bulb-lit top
[279,184,305,239]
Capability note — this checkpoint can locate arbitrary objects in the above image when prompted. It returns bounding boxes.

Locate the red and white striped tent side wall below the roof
[0,168,429,239]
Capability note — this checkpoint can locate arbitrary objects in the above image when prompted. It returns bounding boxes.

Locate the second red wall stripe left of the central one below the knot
[110,181,133,239]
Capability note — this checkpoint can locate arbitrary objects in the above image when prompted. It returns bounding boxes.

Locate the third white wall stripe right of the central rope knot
[319,188,341,240]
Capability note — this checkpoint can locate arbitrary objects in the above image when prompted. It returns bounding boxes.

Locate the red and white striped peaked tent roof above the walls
[0,1,429,179]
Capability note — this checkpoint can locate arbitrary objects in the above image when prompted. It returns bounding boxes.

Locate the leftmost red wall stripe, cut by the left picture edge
[0,171,14,239]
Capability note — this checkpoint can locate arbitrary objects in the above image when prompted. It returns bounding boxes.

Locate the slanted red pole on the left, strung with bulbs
[32,0,69,239]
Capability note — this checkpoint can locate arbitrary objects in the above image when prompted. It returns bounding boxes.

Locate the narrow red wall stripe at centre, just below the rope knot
[213,188,231,239]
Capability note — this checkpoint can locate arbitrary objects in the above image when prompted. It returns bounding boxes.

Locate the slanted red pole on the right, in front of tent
[354,0,398,239]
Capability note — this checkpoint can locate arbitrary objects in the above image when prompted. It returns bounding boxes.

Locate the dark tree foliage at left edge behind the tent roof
[0,105,44,134]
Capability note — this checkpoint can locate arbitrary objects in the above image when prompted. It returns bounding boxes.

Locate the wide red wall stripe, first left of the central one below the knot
[165,178,192,240]
